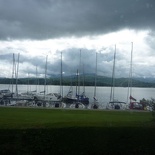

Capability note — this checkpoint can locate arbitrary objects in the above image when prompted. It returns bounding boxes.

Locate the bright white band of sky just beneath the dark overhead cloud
[0,29,149,56]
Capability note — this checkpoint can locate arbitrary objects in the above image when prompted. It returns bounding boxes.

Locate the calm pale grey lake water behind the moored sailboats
[0,84,155,104]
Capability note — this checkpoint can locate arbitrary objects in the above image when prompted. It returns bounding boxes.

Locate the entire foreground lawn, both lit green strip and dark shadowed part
[0,107,155,154]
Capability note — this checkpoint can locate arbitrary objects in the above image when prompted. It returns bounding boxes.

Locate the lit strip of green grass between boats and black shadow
[0,108,152,129]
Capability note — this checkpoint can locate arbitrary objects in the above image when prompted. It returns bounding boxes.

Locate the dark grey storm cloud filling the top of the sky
[0,0,155,40]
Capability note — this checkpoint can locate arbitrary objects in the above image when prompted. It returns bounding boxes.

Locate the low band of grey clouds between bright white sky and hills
[0,44,154,77]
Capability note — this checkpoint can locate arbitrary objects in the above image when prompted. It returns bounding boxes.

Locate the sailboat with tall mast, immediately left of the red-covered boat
[107,45,126,109]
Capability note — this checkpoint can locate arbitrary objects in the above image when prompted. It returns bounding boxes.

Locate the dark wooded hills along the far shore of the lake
[0,74,155,87]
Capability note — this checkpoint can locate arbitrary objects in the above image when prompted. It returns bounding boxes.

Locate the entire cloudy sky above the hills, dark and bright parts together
[0,0,155,77]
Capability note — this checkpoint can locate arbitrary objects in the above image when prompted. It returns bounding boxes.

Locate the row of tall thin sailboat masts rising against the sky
[2,43,133,107]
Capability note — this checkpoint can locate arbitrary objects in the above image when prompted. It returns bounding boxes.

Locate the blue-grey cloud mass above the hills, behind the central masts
[54,48,114,76]
